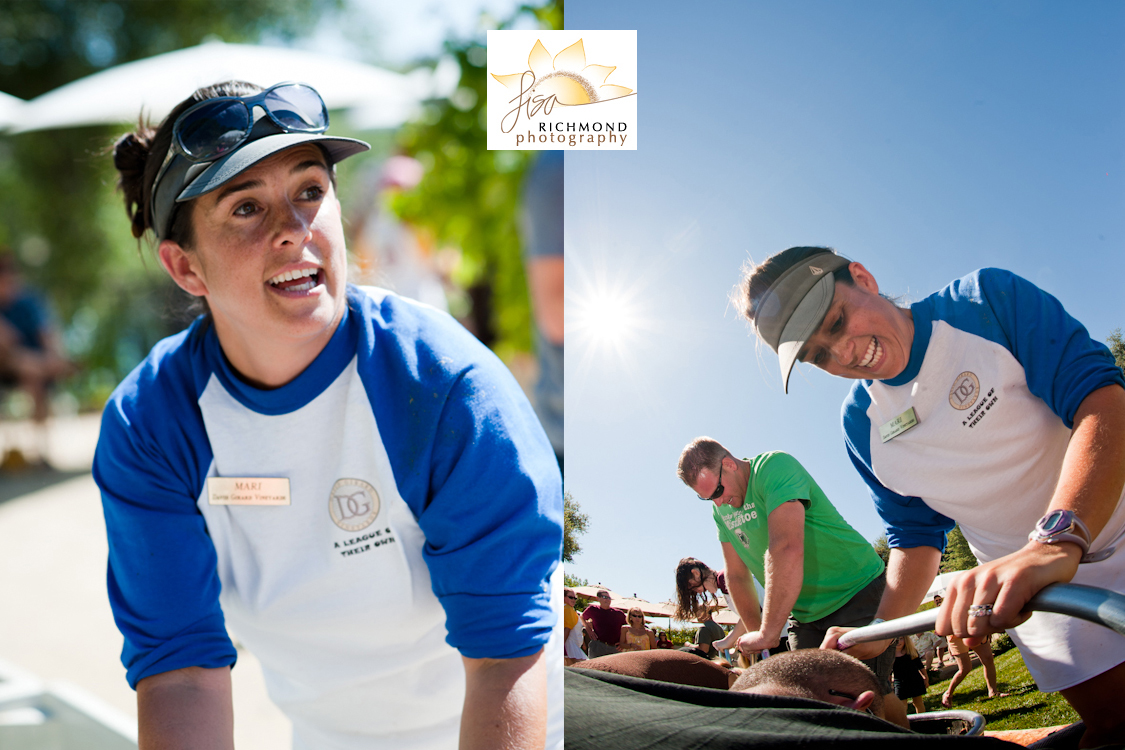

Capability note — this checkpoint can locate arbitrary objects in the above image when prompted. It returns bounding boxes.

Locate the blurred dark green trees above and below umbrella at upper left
[0,0,343,404]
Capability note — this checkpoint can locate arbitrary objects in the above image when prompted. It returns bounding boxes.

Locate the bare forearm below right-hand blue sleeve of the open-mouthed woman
[460,649,547,750]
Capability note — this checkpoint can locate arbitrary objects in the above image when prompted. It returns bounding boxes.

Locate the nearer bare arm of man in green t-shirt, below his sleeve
[738,500,804,652]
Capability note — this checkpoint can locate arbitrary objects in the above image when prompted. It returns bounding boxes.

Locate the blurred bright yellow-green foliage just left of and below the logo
[395,2,563,358]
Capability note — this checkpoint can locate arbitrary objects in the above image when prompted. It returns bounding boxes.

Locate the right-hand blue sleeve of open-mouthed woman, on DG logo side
[357,298,563,658]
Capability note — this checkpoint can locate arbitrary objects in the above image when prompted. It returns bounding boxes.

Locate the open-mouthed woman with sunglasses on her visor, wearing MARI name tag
[101,82,563,750]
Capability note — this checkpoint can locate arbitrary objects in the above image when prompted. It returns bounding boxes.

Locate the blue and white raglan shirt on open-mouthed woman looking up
[93,287,563,750]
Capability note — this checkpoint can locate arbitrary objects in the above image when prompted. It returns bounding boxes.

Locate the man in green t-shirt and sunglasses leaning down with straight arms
[677,437,905,719]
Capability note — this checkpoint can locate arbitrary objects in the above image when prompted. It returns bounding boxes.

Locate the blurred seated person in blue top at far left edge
[0,247,73,469]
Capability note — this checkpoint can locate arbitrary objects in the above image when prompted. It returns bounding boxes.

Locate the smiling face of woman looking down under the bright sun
[798,263,914,380]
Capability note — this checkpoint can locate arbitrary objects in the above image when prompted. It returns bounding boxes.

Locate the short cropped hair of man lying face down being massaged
[730,649,883,716]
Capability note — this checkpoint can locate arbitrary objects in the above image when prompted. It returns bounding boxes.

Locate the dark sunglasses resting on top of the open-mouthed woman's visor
[172,82,329,163]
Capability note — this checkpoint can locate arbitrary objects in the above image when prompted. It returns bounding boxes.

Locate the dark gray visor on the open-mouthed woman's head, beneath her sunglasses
[152,122,371,242]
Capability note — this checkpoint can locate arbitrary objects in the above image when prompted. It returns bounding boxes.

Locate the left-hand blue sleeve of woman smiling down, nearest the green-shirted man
[843,382,954,552]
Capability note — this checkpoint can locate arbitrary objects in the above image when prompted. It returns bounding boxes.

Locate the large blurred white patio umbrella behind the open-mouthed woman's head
[8,42,459,133]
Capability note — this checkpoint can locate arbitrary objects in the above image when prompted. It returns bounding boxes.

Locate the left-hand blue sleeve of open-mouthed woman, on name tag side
[93,330,236,688]
